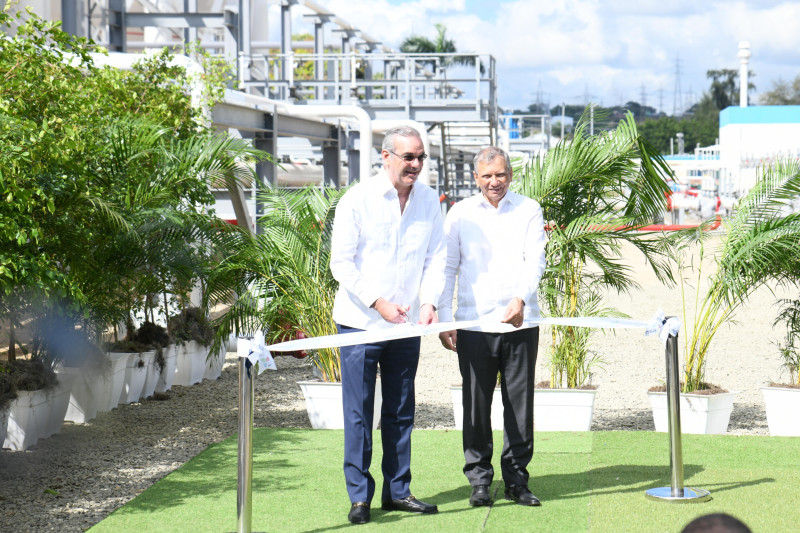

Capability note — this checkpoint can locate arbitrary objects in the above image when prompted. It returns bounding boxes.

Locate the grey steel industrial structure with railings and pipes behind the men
[45,0,549,222]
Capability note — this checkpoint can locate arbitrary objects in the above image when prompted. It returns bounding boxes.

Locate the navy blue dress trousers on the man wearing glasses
[337,325,420,503]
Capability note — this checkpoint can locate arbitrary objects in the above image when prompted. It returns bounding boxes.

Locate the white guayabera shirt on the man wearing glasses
[331,171,447,329]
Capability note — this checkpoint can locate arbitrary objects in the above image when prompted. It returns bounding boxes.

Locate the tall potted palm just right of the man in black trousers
[515,112,672,388]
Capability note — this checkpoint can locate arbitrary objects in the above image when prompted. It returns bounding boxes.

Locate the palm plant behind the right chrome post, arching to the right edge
[682,161,800,392]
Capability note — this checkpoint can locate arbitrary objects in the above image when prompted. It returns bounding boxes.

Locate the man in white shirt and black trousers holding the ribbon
[439,147,546,506]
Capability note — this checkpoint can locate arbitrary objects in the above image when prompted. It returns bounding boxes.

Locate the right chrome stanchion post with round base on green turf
[645,317,711,502]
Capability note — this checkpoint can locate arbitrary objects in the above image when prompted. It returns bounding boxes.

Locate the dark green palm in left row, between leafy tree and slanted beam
[83,121,265,338]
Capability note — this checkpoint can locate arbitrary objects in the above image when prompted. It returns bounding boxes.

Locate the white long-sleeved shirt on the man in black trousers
[439,191,547,322]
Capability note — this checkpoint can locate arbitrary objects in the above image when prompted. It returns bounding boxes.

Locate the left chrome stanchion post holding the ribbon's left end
[236,337,254,533]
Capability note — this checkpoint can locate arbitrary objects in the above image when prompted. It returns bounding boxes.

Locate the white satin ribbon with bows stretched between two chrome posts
[239,309,681,373]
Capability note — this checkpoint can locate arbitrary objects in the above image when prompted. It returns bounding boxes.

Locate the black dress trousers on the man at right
[456,327,539,487]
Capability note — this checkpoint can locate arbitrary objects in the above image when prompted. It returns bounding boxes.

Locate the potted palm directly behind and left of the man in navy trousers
[209,187,342,381]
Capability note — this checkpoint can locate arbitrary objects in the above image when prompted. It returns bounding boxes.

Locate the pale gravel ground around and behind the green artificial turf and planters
[0,238,781,533]
